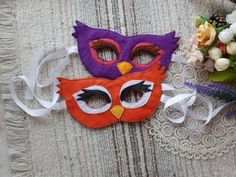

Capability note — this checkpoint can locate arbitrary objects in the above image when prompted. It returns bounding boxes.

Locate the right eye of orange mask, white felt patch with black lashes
[120,80,154,109]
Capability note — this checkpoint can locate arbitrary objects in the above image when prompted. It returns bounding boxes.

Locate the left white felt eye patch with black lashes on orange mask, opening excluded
[73,85,112,114]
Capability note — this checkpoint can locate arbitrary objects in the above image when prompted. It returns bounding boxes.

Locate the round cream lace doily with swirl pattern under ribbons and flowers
[146,60,236,159]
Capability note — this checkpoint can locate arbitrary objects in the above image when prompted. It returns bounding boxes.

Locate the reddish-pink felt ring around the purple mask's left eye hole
[89,38,120,65]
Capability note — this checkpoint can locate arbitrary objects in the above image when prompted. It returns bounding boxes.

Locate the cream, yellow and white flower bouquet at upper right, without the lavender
[187,10,236,82]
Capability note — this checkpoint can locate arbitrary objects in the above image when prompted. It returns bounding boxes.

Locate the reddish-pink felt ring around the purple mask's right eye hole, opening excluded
[131,42,165,68]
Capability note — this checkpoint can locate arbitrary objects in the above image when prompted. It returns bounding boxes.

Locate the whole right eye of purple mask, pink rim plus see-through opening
[131,42,164,68]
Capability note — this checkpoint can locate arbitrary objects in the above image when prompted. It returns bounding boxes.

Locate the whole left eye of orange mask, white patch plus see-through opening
[73,86,112,114]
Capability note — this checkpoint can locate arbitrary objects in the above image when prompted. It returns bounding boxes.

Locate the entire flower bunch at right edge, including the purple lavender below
[185,10,236,117]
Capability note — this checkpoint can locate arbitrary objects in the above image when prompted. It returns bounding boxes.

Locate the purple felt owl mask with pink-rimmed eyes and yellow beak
[72,21,179,79]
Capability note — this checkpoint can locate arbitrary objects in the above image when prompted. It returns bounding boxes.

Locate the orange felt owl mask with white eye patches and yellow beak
[58,63,165,128]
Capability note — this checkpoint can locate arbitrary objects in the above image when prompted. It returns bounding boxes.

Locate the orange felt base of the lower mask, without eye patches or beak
[58,63,165,128]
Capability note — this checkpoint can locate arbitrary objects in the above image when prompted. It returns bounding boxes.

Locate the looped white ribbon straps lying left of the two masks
[9,46,78,117]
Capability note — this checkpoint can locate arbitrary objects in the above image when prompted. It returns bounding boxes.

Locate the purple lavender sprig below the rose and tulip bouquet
[184,82,236,102]
